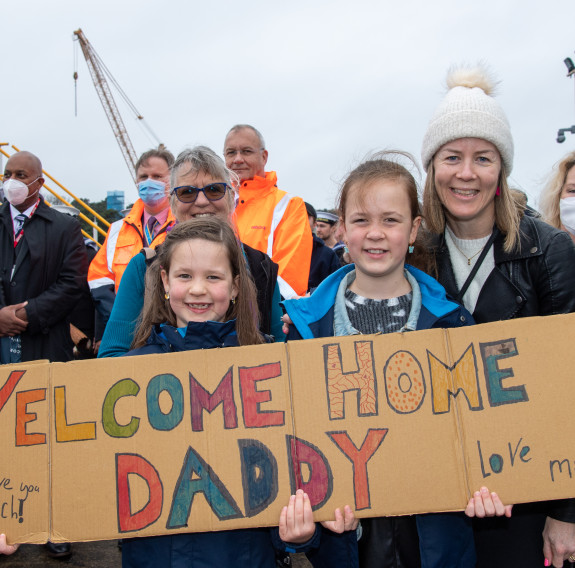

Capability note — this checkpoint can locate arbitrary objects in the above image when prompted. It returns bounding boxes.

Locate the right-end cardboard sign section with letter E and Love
[449,315,575,503]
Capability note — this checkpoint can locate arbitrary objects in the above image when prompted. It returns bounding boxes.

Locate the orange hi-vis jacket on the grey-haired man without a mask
[235,172,313,299]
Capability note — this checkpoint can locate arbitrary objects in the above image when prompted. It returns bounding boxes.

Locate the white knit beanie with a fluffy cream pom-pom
[421,65,513,175]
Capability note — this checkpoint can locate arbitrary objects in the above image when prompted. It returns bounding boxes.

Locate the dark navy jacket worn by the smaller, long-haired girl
[122,320,321,568]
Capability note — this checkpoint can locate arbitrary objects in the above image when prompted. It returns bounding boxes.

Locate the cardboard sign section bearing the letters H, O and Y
[289,330,466,518]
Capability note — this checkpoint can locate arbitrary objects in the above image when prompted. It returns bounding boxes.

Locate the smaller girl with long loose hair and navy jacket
[122,217,338,568]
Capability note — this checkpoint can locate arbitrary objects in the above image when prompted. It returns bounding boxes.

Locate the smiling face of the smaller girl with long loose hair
[161,239,238,327]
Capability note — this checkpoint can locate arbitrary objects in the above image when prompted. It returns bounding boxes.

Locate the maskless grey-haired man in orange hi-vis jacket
[224,124,313,299]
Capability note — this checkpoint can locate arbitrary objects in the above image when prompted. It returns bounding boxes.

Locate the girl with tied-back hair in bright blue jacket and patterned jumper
[284,155,508,568]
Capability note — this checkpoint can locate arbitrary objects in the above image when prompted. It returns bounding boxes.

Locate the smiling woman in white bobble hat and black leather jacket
[418,66,575,568]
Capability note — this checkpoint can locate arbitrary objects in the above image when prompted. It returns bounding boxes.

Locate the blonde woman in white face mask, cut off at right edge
[539,152,575,242]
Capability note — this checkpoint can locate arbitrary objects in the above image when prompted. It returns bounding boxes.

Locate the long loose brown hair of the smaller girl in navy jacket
[132,216,264,348]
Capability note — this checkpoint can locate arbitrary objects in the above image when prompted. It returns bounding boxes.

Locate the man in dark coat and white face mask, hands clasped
[0,152,88,557]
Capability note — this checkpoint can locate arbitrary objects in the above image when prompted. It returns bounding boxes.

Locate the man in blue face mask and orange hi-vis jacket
[88,146,175,344]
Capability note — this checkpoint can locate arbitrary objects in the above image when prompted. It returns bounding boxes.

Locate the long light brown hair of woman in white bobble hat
[423,156,525,252]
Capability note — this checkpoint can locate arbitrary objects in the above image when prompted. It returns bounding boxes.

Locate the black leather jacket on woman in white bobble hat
[432,216,575,568]
